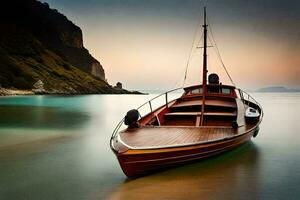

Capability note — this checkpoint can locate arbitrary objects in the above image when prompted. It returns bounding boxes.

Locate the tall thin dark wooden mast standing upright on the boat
[201,7,207,126]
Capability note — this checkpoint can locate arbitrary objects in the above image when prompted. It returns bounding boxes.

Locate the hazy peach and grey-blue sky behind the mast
[46,0,300,90]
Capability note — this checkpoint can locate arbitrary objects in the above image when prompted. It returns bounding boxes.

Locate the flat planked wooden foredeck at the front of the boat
[119,126,251,148]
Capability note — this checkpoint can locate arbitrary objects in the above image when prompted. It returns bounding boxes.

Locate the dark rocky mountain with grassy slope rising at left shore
[0,0,131,93]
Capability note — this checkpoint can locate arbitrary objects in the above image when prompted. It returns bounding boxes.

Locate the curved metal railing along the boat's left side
[111,87,183,145]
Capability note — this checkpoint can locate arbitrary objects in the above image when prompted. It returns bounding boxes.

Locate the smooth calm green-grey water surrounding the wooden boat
[0,93,300,200]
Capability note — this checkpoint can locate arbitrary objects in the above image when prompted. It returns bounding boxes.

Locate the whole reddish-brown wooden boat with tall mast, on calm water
[110,9,263,177]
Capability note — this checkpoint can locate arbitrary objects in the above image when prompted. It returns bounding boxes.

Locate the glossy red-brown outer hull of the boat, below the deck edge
[116,127,258,177]
